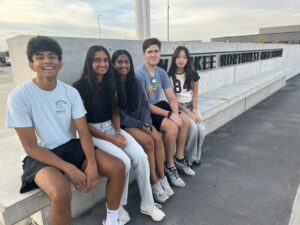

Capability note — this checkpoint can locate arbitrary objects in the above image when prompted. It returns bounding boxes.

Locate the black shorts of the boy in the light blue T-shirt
[20,139,85,193]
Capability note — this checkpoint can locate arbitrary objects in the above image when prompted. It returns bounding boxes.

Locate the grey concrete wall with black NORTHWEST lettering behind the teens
[7,36,300,94]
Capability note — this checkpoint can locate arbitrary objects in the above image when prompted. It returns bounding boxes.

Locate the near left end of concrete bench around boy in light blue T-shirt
[0,135,110,225]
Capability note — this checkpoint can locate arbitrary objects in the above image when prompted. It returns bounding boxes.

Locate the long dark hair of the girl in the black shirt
[81,45,118,112]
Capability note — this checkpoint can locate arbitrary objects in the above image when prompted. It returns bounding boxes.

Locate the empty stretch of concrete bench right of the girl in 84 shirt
[198,68,294,134]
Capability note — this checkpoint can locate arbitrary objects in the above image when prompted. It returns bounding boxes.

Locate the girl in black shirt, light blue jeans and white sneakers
[74,46,165,223]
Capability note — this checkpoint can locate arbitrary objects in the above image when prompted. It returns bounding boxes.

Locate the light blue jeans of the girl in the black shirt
[91,120,154,205]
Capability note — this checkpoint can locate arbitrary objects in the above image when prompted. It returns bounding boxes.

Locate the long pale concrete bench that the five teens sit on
[0,65,294,225]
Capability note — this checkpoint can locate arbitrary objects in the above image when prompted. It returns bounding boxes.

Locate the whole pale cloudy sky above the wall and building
[0,0,300,51]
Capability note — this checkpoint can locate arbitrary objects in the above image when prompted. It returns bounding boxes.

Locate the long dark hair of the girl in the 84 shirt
[168,46,197,91]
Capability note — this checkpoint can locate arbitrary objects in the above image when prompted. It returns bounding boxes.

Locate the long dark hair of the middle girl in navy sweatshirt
[111,49,138,111]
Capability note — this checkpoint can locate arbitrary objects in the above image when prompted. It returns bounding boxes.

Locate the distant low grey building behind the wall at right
[211,25,300,44]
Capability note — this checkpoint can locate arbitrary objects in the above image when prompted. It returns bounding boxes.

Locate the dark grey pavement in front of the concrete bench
[74,75,300,225]
